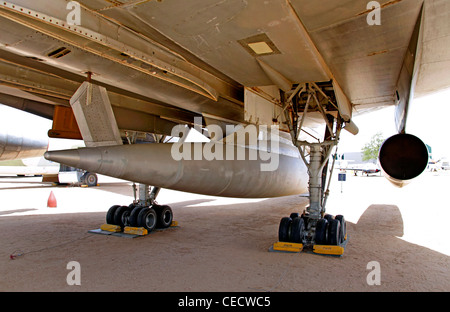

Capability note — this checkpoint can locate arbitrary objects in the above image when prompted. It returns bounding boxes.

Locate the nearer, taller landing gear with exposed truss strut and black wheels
[278,83,346,248]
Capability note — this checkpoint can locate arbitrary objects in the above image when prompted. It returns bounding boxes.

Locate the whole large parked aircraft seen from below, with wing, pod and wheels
[0,0,450,246]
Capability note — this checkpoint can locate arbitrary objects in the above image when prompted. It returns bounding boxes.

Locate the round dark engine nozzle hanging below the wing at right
[378,134,428,187]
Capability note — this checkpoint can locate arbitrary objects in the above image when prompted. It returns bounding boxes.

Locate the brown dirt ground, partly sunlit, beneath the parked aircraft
[0,172,450,292]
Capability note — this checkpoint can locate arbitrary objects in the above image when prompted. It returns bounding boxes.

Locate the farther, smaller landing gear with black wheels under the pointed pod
[106,184,173,233]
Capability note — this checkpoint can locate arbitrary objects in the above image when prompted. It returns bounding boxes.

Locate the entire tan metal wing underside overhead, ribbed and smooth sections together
[0,0,450,132]
